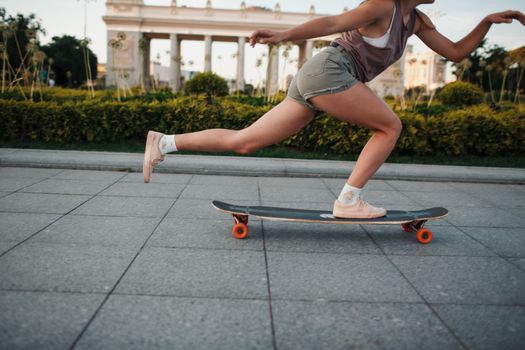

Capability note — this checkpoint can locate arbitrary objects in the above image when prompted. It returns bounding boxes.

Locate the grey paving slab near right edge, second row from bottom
[390,256,525,304]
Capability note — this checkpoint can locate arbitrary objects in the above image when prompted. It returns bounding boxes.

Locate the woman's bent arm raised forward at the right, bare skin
[415,10,525,62]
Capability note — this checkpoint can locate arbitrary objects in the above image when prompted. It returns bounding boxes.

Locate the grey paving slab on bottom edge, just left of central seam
[75,295,272,350]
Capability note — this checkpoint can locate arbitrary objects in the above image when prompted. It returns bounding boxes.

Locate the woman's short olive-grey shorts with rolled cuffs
[287,46,359,111]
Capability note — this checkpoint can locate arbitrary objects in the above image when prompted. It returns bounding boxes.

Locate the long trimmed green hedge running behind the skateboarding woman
[0,96,525,156]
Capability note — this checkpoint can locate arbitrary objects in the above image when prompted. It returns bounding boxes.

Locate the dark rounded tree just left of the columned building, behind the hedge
[42,35,97,87]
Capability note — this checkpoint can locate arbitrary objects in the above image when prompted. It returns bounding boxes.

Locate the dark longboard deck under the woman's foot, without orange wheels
[212,201,448,225]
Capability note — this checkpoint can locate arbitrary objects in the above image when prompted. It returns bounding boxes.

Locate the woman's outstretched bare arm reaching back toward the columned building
[250,0,393,47]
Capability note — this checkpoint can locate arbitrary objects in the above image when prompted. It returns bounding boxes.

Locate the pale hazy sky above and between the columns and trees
[0,0,525,85]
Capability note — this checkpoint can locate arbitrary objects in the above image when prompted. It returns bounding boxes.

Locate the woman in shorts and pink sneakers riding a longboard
[143,0,525,218]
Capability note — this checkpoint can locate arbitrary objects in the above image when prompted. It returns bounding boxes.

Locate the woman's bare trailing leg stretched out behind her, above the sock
[175,98,315,154]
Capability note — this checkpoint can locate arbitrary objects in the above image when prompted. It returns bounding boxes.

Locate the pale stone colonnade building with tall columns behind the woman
[103,0,337,94]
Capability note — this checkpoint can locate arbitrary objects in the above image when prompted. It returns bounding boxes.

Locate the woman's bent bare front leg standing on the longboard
[310,83,402,188]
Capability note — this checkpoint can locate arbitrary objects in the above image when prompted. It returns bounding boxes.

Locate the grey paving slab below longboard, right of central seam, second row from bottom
[267,251,422,302]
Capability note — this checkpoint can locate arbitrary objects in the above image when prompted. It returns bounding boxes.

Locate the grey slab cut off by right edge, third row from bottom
[462,227,525,258]
